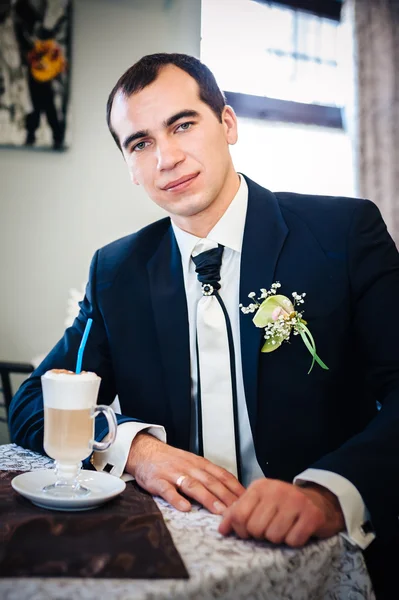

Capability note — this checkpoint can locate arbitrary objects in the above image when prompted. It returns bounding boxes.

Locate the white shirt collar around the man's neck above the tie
[172,175,248,268]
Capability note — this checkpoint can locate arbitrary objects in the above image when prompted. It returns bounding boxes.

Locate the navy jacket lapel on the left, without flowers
[147,227,191,448]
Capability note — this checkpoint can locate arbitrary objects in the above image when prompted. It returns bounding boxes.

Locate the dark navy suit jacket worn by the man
[10,175,399,538]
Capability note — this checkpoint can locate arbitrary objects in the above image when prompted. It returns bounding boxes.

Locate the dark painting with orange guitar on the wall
[0,0,72,151]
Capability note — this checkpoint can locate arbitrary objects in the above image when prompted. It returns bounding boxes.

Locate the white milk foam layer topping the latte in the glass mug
[42,369,101,410]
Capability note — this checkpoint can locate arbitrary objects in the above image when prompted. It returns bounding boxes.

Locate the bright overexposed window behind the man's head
[201,0,355,196]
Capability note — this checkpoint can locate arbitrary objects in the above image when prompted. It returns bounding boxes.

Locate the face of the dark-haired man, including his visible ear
[111,65,237,220]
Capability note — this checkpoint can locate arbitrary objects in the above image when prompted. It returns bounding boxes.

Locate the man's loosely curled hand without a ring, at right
[219,479,345,547]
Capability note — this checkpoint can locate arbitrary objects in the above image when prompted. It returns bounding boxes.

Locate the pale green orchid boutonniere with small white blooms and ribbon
[240,282,328,374]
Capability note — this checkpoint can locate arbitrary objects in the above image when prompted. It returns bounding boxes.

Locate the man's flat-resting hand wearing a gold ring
[125,433,245,514]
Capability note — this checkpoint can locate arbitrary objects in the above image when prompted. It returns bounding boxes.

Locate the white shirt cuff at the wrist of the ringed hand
[91,421,166,481]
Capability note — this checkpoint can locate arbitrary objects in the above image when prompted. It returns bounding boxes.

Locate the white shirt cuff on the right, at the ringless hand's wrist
[294,469,375,550]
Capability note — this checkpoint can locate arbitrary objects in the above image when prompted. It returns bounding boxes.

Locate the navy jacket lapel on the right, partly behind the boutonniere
[240,177,288,438]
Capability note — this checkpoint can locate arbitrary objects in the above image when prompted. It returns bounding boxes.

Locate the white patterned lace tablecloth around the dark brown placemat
[0,444,375,600]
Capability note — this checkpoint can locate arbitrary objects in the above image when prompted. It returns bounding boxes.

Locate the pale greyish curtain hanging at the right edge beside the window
[344,0,399,246]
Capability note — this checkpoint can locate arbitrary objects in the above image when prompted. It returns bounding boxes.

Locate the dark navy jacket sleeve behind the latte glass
[9,252,142,453]
